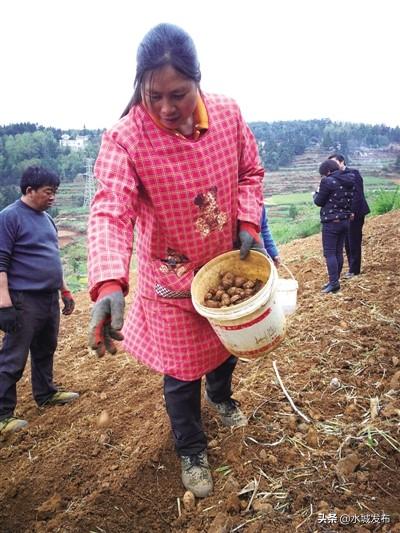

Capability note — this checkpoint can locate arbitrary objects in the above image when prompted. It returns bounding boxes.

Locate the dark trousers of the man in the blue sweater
[0,291,60,420]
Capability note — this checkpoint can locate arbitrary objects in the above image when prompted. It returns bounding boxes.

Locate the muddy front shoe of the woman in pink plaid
[181,450,213,498]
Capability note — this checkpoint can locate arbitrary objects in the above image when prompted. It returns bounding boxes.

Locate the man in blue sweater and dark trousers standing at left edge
[0,167,79,435]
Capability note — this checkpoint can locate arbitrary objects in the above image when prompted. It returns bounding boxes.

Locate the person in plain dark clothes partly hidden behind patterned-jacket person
[329,154,370,279]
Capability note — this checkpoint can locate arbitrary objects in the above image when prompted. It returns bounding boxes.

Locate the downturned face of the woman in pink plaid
[142,65,198,135]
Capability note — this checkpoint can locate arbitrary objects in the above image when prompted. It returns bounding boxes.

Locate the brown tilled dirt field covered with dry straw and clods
[0,211,400,533]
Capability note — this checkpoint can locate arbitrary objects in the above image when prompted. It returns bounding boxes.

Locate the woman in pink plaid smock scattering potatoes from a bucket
[89,24,264,497]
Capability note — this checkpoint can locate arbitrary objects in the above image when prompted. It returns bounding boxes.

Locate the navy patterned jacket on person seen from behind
[314,170,354,222]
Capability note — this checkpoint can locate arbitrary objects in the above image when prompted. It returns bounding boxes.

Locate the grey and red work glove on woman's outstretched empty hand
[89,281,125,357]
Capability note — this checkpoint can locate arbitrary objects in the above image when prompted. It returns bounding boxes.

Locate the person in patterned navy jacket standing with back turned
[314,159,354,294]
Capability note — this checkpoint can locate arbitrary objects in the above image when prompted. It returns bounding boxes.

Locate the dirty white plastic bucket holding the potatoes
[191,250,286,359]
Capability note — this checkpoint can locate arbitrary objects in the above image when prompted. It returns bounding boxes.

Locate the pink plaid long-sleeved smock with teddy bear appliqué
[88,95,264,381]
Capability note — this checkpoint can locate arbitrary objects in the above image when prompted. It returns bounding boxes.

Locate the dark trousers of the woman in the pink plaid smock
[164,355,237,455]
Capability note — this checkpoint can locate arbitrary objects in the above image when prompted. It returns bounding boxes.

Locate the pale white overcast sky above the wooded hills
[0,0,400,129]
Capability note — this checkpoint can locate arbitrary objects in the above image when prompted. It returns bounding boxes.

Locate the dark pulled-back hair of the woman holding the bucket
[121,23,201,118]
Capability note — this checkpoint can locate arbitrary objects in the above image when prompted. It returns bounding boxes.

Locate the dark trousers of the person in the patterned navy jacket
[322,219,349,283]
